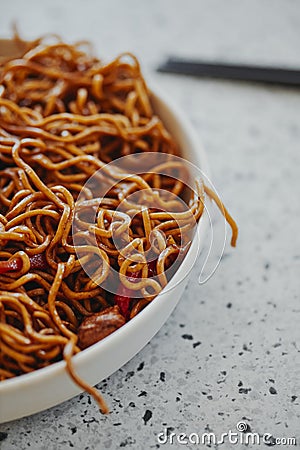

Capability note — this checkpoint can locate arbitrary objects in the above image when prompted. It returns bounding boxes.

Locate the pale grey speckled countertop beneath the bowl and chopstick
[0,0,300,450]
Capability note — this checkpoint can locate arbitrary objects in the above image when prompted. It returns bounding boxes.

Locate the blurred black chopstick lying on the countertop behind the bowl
[157,57,300,86]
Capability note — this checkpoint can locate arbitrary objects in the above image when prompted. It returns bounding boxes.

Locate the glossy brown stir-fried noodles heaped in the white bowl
[0,38,237,412]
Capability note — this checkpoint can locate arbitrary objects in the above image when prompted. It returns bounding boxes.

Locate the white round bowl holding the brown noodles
[0,85,209,423]
